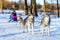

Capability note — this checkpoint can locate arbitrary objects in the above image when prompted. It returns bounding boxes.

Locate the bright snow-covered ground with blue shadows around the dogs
[0,12,60,40]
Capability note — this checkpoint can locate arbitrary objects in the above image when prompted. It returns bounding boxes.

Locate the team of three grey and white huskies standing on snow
[17,13,50,36]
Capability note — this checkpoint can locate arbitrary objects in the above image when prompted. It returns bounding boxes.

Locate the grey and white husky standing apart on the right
[40,13,50,36]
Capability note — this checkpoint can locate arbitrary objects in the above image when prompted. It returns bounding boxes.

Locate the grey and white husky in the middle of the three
[24,14,34,34]
